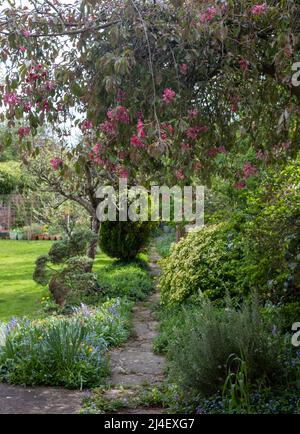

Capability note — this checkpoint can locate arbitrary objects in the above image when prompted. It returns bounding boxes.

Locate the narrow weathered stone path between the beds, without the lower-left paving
[103,249,165,414]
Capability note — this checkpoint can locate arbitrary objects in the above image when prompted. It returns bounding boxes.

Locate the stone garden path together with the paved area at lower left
[0,244,165,414]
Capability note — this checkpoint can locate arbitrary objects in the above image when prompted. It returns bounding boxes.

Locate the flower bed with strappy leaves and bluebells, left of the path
[0,299,132,388]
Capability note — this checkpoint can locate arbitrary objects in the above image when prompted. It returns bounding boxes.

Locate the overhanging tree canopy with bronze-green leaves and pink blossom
[0,0,300,244]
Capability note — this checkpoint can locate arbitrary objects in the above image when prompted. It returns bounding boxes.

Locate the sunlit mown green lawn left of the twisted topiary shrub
[0,240,51,320]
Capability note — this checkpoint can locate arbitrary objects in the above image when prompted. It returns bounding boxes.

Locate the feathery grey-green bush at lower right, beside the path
[168,300,286,397]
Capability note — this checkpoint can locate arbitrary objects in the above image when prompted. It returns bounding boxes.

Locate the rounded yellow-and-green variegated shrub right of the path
[160,224,241,305]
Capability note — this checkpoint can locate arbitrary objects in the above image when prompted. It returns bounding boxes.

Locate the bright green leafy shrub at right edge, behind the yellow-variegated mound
[243,157,300,303]
